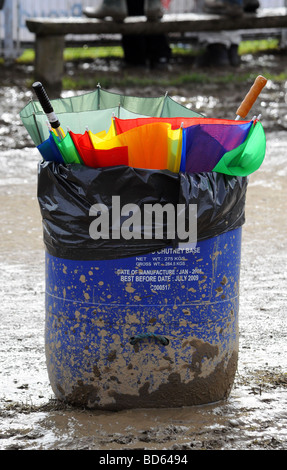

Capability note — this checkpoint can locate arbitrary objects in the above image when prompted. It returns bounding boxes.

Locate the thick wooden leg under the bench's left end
[35,35,65,97]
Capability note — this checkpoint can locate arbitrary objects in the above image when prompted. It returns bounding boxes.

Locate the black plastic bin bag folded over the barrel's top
[38,161,248,260]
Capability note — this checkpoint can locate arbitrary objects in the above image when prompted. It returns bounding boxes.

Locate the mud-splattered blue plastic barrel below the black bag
[45,227,241,410]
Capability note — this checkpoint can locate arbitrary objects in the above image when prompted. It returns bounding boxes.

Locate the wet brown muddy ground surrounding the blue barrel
[0,49,287,452]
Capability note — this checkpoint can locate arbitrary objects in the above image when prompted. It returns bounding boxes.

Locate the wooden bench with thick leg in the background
[26,8,287,90]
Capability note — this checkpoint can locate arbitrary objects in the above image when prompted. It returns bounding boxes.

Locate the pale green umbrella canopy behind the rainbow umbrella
[20,86,201,146]
